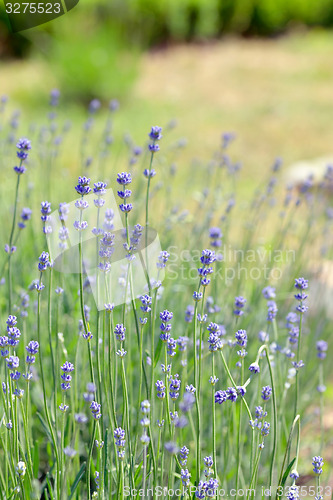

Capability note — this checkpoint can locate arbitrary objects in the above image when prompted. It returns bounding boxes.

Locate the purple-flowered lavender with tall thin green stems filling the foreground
[0,94,333,500]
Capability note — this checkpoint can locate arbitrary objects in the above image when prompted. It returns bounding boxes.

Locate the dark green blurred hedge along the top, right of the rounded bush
[108,0,333,42]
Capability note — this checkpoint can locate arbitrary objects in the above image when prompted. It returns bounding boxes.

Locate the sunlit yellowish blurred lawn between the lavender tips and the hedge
[0,31,333,196]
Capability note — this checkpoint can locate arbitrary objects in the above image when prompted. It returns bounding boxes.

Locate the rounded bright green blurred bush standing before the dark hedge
[47,2,139,101]
